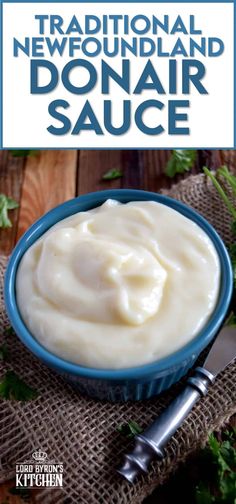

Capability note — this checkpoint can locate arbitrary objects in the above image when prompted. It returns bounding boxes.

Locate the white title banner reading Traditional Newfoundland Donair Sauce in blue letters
[1,2,234,149]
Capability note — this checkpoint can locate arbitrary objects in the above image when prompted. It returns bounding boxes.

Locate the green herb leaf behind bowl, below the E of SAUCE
[165,149,197,177]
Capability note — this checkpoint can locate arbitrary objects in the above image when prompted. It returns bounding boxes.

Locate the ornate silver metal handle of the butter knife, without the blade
[117,367,215,483]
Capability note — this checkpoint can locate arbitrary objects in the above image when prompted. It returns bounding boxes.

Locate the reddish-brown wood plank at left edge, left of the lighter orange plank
[0,151,25,255]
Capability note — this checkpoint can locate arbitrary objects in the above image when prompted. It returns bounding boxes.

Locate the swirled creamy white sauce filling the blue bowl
[16,200,220,369]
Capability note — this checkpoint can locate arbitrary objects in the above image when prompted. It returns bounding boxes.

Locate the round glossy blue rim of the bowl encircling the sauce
[4,189,233,380]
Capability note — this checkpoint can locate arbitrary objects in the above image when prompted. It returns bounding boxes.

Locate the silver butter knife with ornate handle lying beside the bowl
[117,326,236,483]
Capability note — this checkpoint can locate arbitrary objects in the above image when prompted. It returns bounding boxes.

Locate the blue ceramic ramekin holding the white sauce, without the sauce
[5,189,233,401]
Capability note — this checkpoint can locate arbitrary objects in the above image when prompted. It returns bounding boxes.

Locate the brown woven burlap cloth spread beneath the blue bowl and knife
[0,176,236,504]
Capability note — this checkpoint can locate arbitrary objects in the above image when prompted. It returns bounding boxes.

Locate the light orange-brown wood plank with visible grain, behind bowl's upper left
[17,150,77,239]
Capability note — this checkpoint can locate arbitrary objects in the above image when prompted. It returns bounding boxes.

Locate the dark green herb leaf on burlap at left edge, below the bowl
[0,371,38,401]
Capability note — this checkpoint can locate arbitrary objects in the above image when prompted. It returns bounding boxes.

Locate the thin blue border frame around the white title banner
[0,0,236,151]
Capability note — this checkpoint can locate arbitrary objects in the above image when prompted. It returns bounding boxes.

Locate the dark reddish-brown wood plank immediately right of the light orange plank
[77,150,123,194]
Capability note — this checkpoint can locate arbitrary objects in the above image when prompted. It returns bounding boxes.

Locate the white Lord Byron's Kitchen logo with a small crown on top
[16,449,63,488]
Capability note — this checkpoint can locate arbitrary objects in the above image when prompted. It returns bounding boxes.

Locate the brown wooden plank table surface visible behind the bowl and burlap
[0,150,236,504]
